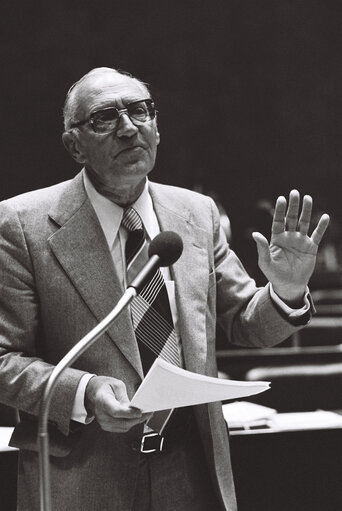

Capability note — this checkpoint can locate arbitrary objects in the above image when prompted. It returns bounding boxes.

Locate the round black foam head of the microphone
[148,231,183,266]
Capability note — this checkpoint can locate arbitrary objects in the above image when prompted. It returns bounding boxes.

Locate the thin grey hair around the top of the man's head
[63,67,150,131]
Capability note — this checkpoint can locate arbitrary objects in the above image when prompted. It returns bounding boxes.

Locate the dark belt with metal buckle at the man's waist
[140,407,196,454]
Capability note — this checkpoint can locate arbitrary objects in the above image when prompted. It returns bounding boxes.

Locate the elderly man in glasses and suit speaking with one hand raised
[0,68,329,511]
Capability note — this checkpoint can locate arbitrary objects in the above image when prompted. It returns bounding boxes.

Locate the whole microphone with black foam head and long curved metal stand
[37,231,183,511]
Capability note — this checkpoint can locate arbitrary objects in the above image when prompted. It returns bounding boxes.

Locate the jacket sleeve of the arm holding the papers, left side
[0,201,85,435]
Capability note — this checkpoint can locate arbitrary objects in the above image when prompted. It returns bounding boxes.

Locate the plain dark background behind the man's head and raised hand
[0,0,342,280]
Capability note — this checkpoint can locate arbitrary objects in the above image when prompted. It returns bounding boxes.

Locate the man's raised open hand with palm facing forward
[253,190,329,306]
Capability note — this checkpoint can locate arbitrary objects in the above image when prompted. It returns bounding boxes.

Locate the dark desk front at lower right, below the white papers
[230,428,342,511]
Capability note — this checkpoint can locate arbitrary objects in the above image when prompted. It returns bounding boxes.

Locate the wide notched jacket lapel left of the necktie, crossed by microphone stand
[49,173,143,376]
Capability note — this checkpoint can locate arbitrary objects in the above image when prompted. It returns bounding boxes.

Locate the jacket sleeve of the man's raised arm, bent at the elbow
[212,198,311,347]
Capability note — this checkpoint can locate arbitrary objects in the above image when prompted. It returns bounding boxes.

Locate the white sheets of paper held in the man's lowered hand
[131,358,270,412]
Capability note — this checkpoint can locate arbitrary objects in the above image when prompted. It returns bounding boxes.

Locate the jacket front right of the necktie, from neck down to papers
[150,183,209,373]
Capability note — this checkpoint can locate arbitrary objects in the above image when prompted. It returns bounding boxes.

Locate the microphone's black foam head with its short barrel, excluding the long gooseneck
[128,231,183,293]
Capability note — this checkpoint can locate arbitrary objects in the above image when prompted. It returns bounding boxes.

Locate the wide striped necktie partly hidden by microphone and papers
[121,207,181,432]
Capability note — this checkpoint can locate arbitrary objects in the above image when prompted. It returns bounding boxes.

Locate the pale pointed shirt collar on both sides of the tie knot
[83,171,159,247]
